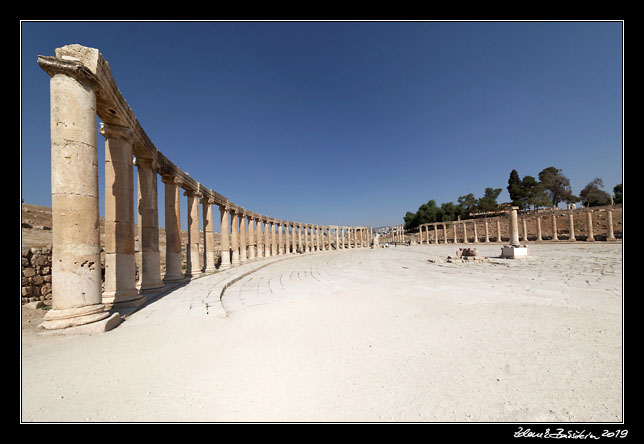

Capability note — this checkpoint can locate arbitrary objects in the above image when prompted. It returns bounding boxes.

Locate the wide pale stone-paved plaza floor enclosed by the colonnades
[21,242,623,422]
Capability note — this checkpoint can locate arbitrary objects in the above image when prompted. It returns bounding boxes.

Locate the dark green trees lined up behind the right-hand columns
[403,167,622,230]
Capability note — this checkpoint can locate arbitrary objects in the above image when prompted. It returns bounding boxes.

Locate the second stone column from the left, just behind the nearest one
[100,124,142,306]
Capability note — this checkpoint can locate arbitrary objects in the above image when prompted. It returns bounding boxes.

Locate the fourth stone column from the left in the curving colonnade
[161,176,183,282]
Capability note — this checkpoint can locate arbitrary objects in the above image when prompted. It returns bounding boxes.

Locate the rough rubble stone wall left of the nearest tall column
[22,247,51,304]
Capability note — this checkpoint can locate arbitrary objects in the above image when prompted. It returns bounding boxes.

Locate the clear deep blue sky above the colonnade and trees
[21,21,623,228]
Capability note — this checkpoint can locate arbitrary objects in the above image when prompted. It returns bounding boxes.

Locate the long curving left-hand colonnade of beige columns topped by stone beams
[38,45,372,329]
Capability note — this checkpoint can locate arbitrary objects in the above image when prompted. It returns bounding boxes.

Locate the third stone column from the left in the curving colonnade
[135,158,165,291]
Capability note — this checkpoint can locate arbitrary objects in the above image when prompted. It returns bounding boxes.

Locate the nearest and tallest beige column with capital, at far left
[38,59,109,329]
